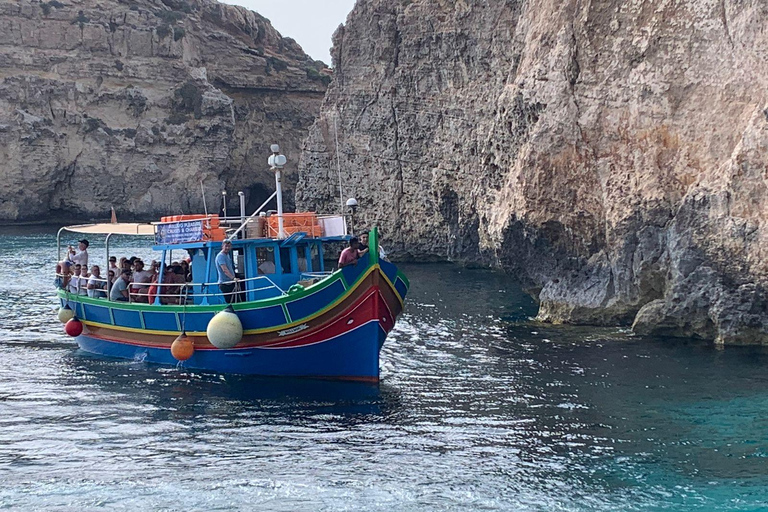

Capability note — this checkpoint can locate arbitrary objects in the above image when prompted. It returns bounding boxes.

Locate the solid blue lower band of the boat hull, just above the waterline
[77,320,386,381]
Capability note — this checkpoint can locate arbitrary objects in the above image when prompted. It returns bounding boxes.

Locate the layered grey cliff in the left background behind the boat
[0,0,328,221]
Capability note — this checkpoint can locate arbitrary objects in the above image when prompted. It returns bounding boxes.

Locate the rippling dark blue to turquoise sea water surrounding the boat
[0,229,768,511]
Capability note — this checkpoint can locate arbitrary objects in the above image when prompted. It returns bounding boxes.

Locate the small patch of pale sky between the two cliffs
[222,0,355,66]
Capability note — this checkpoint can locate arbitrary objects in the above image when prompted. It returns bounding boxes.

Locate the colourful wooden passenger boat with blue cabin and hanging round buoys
[57,146,409,382]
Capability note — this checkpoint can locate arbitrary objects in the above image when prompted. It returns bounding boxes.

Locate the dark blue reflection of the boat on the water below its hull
[66,350,400,423]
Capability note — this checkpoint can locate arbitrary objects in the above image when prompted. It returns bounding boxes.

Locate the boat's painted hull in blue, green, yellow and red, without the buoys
[60,258,409,382]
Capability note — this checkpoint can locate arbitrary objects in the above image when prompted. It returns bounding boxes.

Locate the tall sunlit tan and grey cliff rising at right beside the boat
[297,0,768,344]
